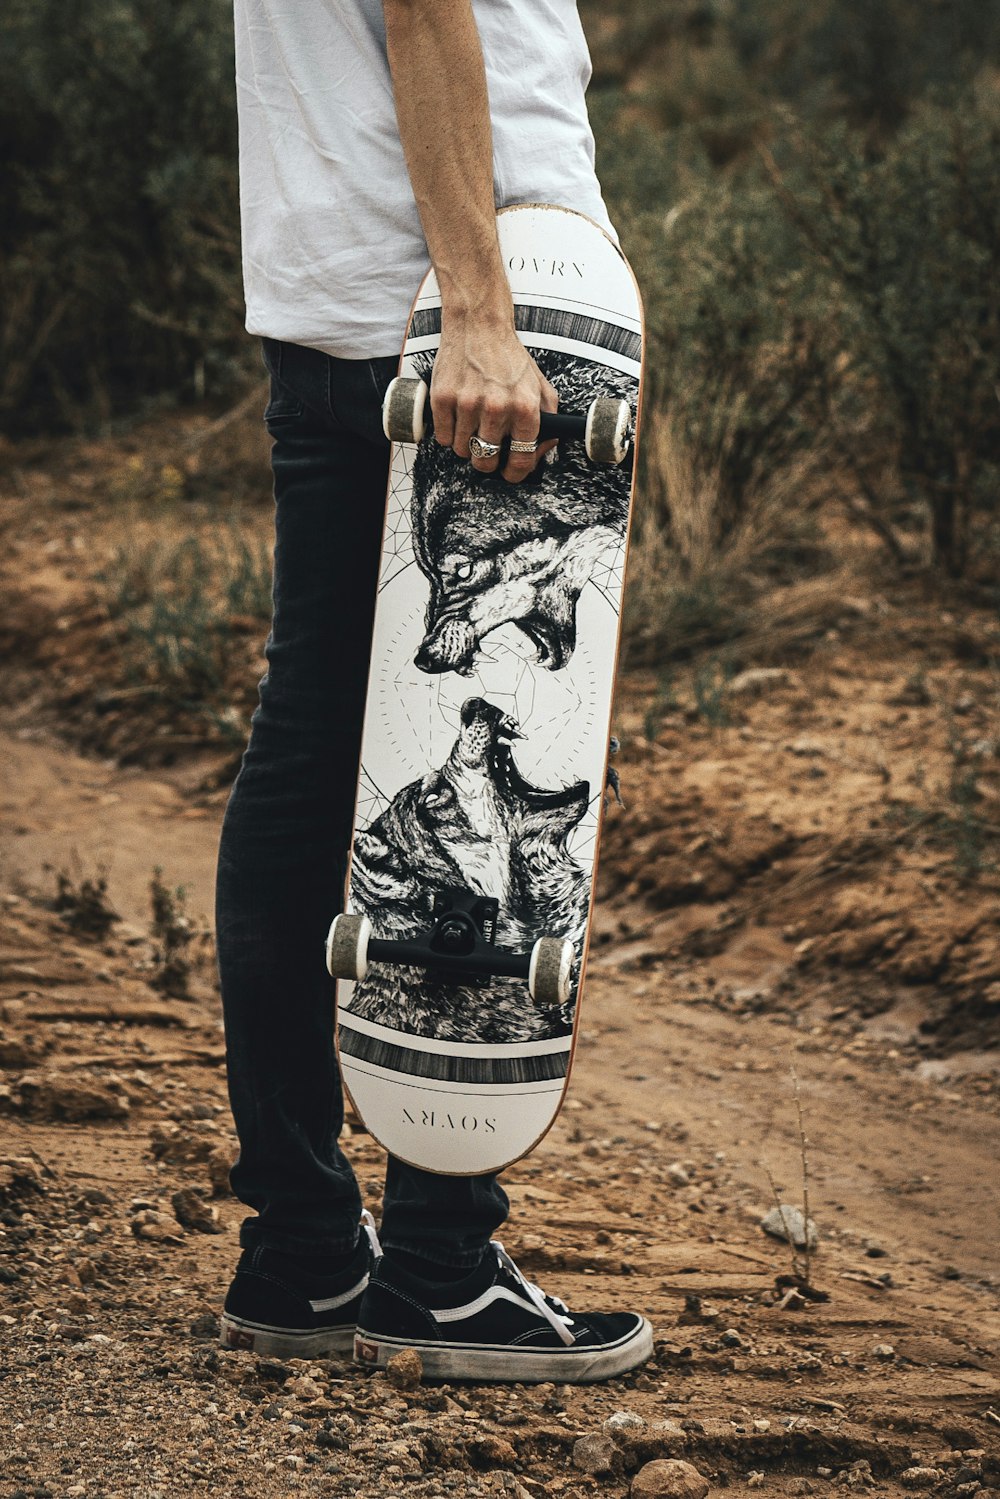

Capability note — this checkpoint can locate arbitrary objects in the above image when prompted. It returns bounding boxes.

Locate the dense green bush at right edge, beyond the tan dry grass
[777,91,1000,577]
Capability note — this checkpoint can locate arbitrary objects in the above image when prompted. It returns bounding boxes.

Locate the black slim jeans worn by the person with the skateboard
[216,340,508,1267]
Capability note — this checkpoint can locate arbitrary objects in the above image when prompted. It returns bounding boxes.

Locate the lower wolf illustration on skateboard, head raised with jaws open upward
[349,697,591,1043]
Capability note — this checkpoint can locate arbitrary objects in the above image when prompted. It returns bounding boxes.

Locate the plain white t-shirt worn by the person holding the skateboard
[235,0,610,358]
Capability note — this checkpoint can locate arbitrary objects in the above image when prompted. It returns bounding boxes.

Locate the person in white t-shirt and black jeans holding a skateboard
[216,0,652,1382]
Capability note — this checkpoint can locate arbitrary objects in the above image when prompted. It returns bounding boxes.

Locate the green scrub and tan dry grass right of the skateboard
[603,87,1000,626]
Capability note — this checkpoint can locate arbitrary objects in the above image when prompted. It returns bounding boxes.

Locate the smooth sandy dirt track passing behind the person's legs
[0,736,1000,1289]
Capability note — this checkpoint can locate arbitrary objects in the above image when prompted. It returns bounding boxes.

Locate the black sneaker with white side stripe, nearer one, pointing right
[354,1240,652,1384]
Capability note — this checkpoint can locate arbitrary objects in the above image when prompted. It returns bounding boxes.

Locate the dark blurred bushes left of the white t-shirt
[0,0,247,433]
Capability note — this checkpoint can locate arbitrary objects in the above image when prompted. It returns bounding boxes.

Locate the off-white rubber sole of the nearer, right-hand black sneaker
[354,1318,652,1385]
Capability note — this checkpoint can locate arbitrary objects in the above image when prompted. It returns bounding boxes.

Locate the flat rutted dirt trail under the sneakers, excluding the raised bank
[0,739,1000,1499]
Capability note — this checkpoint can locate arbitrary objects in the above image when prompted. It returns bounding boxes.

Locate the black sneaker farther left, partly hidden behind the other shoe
[219,1211,382,1358]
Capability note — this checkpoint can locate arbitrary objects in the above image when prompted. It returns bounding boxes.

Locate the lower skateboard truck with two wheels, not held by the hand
[327,890,574,1004]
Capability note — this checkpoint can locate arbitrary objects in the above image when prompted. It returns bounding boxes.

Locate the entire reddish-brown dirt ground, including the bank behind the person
[0,416,1000,1499]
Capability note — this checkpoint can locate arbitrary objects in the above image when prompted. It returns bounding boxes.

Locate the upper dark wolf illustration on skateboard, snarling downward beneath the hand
[411,349,637,673]
